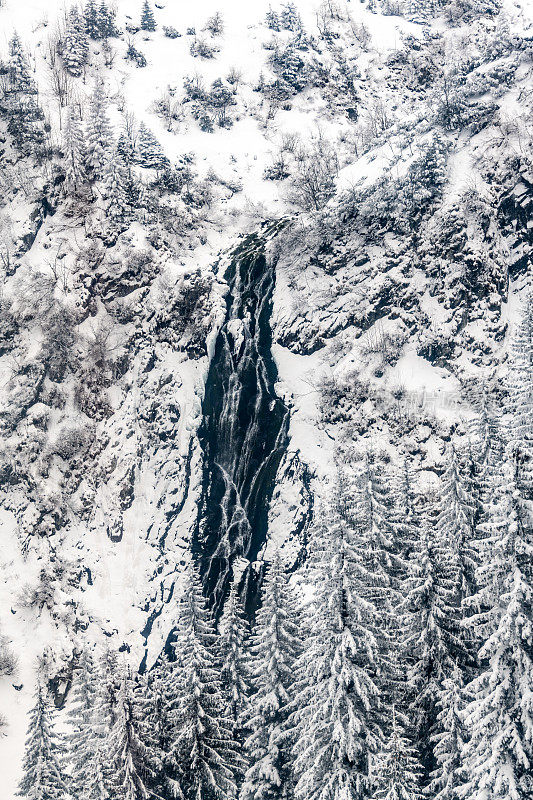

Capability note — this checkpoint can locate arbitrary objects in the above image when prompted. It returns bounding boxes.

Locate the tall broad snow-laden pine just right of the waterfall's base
[290,482,381,800]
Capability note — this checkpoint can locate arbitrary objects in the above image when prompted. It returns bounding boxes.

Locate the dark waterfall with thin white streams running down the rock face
[195,226,289,613]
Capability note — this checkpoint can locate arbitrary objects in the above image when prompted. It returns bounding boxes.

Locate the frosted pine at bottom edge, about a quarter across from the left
[108,675,159,800]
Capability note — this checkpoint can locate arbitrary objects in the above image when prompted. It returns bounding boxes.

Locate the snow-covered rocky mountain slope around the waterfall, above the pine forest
[0,0,533,798]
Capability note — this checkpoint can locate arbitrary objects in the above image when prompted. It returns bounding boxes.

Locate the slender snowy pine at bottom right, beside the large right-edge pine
[427,668,466,800]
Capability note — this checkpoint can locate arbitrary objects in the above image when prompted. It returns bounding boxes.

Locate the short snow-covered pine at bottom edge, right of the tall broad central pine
[371,705,423,800]
